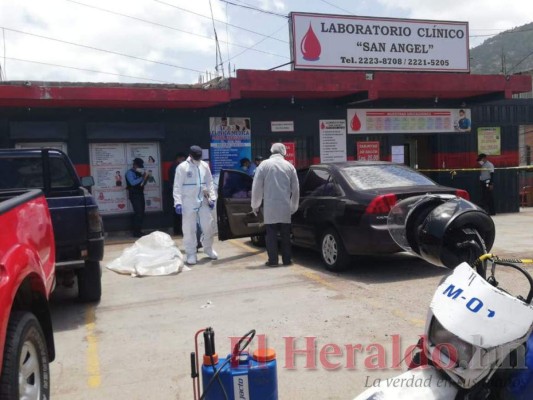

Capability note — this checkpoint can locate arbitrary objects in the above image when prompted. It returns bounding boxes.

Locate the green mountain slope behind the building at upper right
[470,22,533,75]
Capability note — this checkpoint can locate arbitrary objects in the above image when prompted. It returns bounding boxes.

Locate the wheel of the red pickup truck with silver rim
[0,312,50,400]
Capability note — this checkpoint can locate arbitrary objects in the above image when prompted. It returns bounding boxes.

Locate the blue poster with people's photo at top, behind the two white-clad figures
[209,117,252,175]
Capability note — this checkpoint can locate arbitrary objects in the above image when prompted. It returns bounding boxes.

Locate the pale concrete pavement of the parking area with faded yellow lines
[51,212,533,400]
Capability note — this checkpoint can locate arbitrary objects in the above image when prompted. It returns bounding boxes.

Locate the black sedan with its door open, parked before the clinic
[217,161,469,271]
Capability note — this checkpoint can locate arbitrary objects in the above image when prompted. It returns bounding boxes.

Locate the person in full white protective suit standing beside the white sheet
[173,146,218,265]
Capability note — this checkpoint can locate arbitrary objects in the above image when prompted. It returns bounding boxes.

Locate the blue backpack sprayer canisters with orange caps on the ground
[198,335,278,400]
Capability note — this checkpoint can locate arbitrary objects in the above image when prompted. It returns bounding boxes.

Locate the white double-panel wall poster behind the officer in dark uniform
[89,143,162,215]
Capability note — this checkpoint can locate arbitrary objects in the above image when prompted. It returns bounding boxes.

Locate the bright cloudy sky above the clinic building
[0,0,533,84]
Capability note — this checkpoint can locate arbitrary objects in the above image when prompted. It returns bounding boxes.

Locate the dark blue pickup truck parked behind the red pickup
[0,149,104,302]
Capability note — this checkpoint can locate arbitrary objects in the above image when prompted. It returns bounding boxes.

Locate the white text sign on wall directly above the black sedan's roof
[318,119,346,163]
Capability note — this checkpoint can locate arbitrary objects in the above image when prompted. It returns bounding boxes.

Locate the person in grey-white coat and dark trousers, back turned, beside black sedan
[251,143,300,267]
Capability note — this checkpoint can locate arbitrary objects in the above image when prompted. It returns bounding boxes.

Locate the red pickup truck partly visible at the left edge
[0,190,55,400]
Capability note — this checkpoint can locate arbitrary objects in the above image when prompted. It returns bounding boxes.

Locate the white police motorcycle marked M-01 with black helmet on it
[355,195,533,400]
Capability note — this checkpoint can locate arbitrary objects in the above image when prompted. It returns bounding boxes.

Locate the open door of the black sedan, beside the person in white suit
[217,169,265,240]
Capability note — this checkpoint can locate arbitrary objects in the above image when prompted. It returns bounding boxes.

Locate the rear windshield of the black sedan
[342,164,435,190]
